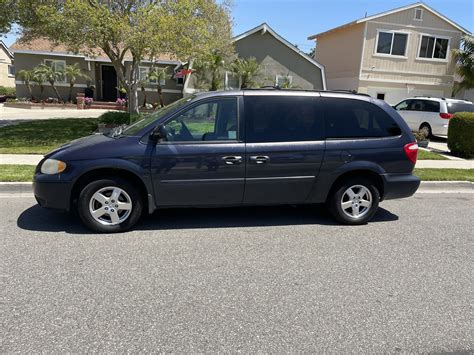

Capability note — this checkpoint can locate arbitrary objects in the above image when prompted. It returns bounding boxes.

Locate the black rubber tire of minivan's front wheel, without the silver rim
[77,178,143,233]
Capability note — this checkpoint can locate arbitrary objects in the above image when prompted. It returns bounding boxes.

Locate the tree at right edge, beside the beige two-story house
[453,35,474,96]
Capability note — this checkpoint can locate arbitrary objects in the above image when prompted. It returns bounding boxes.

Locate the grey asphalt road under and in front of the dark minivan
[0,194,474,353]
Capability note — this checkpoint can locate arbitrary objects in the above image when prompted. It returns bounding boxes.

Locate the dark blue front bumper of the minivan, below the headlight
[33,179,72,211]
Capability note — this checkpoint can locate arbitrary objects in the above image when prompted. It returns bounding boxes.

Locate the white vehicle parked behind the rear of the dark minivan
[394,96,474,137]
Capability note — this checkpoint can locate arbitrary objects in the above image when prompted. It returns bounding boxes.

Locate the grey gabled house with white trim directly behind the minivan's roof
[184,23,326,94]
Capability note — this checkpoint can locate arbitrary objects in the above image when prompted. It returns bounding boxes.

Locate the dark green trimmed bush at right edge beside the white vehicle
[448,112,474,159]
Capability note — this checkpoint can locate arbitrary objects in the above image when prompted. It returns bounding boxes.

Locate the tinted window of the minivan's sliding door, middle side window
[244,96,324,143]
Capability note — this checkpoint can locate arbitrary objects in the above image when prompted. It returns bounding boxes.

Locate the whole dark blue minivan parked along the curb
[34,89,420,232]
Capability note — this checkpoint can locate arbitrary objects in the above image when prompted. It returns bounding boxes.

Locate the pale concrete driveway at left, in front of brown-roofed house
[0,104,109,127]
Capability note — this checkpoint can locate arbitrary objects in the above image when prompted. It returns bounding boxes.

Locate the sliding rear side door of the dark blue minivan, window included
[244,94,325,204]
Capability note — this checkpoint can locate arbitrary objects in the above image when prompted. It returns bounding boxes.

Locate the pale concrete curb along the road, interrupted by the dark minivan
[0,181,474,195]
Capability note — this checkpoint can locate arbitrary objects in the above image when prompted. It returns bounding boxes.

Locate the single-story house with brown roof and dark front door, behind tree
[11,38,183,104]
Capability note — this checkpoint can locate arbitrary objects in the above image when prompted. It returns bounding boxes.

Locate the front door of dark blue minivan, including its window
[151,97,245,206]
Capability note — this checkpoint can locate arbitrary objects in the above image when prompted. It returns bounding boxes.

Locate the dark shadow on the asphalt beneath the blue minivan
[17,205,398,234]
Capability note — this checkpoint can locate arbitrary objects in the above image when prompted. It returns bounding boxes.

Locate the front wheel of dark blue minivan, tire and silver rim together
[78,179,143,233]
